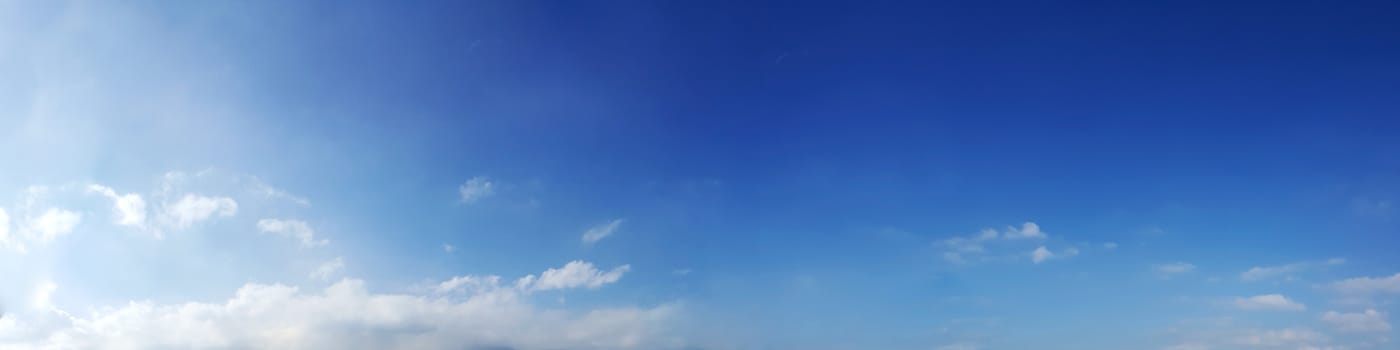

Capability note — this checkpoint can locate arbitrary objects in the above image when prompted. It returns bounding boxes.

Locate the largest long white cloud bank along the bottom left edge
[0,280,685,349]
